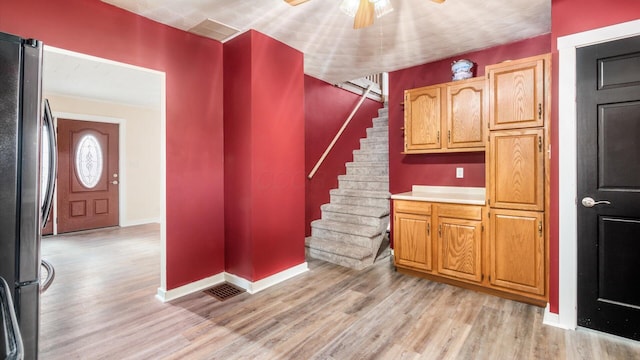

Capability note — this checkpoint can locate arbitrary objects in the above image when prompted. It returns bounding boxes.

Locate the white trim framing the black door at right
[556,20,640,329]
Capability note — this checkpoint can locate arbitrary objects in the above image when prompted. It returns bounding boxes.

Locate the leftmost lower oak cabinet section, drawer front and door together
[393,200,433,271]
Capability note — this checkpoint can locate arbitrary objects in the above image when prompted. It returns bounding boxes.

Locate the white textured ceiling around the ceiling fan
[102,0,551,83]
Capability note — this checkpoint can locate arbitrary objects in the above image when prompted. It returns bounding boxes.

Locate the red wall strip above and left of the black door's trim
[549,0,640,314]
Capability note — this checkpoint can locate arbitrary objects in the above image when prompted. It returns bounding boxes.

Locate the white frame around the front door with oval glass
[51,114,129,235]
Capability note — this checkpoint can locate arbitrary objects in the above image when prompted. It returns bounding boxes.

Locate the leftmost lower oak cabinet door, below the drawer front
[393,212,433,271]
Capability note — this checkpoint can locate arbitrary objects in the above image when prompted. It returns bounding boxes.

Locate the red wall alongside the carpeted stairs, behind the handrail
[304,76,382,236]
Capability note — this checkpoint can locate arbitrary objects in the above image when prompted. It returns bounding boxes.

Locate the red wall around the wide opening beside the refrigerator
[0,0,224,289]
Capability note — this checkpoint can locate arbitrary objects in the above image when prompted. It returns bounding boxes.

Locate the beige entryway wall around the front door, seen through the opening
[44,93,161,226]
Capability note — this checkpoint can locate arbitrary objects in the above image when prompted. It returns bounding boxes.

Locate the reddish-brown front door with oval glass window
[58,119,120,233]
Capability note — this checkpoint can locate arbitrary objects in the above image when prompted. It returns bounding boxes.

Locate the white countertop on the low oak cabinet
[391,185,486,205]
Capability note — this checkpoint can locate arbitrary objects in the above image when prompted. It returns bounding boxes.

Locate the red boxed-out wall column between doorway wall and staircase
[224,31,305,281]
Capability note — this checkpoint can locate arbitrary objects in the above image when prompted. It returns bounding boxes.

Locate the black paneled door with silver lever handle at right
[576,37,640,340]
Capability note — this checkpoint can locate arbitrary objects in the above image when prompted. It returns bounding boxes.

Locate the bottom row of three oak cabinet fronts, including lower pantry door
[393,200,547,306]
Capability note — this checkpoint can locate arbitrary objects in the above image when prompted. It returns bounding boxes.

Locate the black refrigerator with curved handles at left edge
[0,33,55,359]
